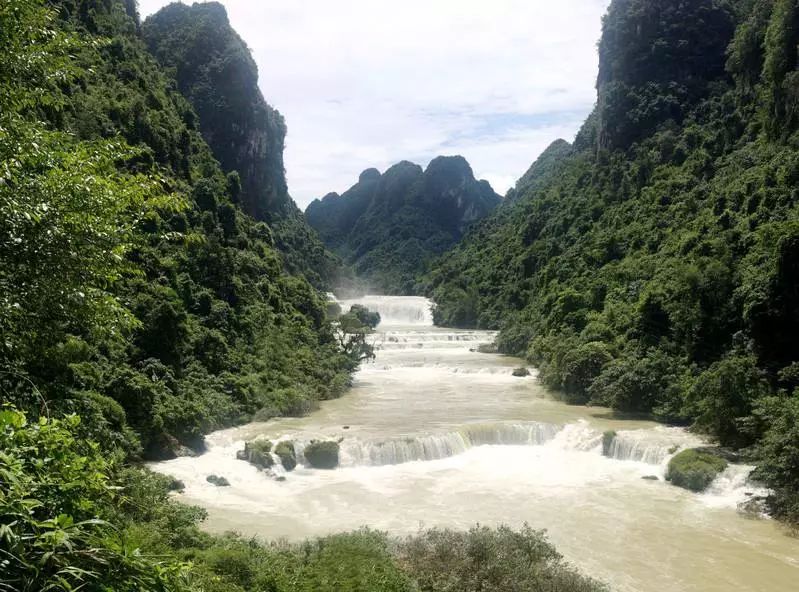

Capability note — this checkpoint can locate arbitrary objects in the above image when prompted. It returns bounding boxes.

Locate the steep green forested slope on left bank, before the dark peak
[0,0,357,457]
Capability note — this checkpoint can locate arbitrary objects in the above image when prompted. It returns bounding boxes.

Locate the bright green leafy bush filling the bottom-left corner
[0,408,183,592]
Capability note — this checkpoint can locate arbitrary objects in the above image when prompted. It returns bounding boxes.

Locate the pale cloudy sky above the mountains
[139,0,609,209]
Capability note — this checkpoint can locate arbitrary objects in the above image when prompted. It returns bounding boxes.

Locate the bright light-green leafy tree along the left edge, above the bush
[0,0,178,394]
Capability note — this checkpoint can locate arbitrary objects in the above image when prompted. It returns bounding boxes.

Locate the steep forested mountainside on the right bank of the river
[428,0,799,520]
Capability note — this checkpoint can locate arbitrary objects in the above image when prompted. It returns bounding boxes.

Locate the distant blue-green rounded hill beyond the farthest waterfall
[305,156,500,294]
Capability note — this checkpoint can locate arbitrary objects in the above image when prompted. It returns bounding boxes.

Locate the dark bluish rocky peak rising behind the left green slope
[142,2,339,287]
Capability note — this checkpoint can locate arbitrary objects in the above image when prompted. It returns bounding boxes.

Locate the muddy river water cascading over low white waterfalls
[153,296,799,592]
